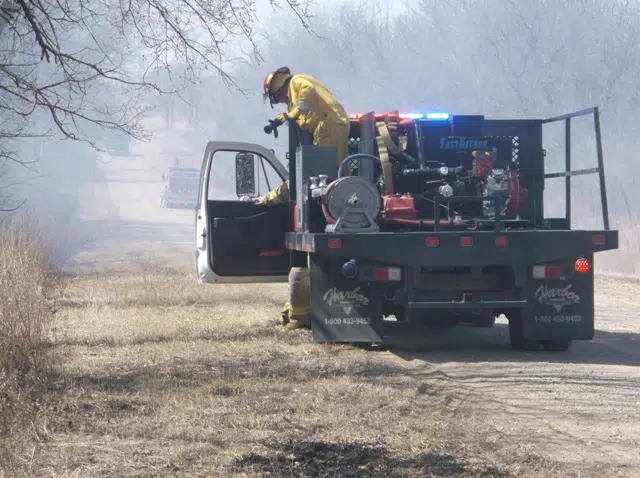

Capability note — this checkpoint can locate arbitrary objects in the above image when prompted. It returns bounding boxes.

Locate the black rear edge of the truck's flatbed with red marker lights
[285,230,618,267]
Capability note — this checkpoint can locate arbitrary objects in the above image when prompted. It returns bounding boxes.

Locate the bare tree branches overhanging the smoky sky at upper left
[0,0,313,154]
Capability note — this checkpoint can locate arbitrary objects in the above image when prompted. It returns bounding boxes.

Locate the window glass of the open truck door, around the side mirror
[207,151,283,201]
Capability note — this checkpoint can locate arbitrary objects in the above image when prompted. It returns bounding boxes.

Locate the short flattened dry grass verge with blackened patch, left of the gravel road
[18,271,596,478]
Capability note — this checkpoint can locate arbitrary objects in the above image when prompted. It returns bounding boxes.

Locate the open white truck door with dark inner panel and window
[195,141,290,284]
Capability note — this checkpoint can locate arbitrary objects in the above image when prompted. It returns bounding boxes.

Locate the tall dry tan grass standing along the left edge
[0,215,60,476]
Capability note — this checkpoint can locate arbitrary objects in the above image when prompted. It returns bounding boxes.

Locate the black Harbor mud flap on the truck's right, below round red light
[522,256,594,340]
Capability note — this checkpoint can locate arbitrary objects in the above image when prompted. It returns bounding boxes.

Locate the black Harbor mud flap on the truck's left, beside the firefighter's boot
[309,254,383,343]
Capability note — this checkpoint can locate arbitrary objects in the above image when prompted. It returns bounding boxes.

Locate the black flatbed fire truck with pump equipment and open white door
[195,107,618,350]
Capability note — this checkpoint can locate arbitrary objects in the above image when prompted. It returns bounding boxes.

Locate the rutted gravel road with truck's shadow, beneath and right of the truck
[380,280,640,476]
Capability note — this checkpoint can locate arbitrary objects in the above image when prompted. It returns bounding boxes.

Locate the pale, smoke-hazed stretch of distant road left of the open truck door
[66,144,195,273]
